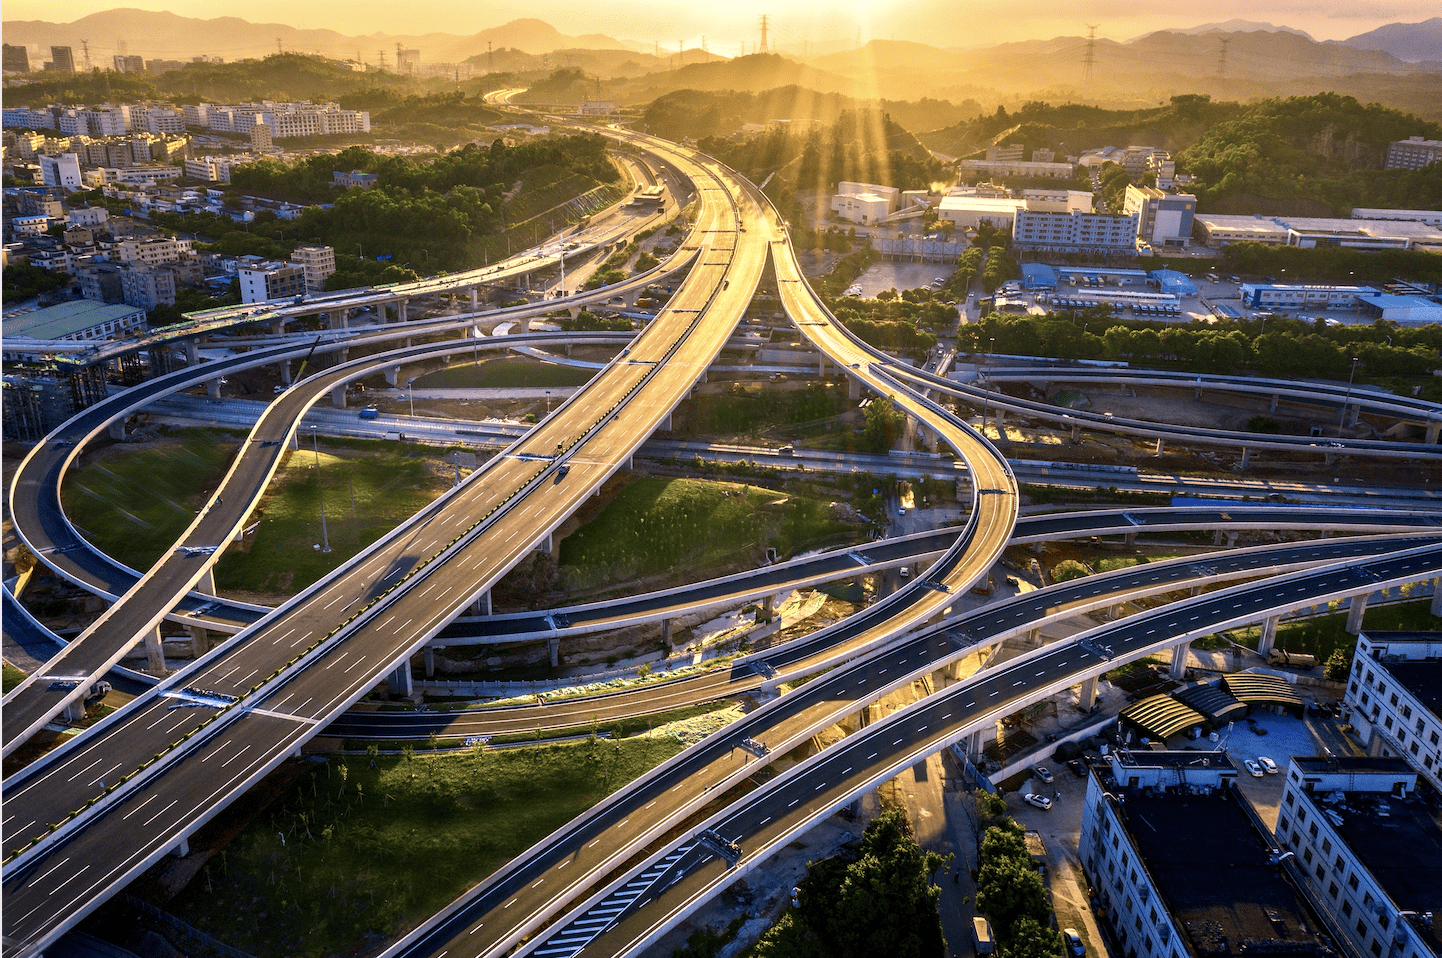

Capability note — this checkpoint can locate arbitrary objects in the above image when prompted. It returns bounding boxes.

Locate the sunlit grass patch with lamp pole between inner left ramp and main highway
[215,440,450,594]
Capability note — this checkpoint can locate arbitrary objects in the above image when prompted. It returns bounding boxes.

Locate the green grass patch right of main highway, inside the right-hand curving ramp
[561,478,862,586]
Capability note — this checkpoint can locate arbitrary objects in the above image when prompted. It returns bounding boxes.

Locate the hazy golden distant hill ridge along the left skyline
[4,7,624,66]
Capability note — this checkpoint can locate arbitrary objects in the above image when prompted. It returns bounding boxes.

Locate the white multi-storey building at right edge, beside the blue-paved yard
[1345,630,1442,792]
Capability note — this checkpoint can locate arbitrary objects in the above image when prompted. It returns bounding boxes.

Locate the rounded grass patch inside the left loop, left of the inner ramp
[61,429,244,571]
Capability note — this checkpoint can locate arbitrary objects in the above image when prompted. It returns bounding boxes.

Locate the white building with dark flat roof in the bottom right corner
[1276,755,1442,958]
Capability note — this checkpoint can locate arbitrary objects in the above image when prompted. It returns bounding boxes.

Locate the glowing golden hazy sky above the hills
[4,0,1442,47]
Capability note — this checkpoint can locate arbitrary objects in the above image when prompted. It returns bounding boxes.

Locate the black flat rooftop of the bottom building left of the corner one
[1119,791,1335,957]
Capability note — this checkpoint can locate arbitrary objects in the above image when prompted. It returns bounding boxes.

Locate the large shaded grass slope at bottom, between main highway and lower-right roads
[166,734,682,958]
